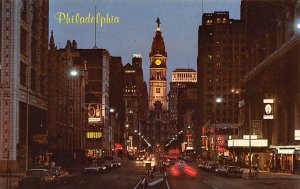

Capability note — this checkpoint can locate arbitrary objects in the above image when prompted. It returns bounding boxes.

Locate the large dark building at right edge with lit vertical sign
[238,0,300,173]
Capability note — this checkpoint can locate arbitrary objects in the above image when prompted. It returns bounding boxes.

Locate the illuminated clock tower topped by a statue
[149,18,167,110]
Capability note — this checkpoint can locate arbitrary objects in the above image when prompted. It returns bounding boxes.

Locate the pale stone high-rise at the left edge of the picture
[0,0,49,170]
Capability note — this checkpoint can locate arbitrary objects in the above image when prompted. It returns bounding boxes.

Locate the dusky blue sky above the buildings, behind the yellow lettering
[49,0,240,83]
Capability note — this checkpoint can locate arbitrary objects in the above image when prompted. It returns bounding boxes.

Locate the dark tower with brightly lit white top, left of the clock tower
[123,54,148,154]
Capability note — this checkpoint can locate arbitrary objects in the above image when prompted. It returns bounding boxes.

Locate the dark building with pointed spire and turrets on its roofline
[47,35,88,166]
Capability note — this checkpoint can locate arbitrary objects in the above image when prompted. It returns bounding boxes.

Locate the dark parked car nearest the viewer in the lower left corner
[18,169,55,189]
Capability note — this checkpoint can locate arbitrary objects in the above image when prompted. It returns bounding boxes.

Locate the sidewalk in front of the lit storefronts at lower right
[242,168,300,180]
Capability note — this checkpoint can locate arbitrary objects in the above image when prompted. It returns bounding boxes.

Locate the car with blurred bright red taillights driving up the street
[169,161,197,178]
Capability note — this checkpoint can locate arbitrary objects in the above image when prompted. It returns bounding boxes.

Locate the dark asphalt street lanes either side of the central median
[0,160,300,189]
